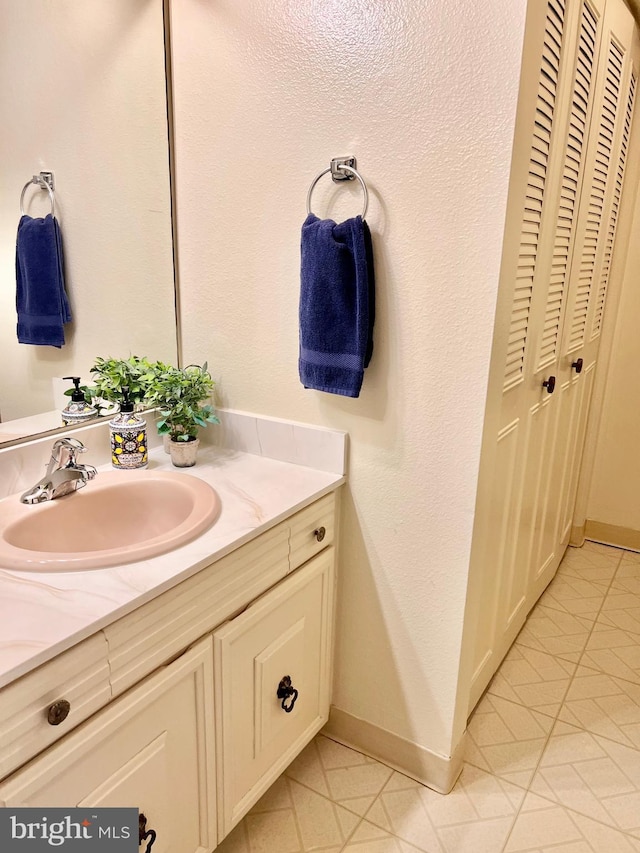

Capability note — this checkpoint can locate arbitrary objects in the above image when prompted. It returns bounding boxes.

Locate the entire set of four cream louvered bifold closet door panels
[470,0,633,708]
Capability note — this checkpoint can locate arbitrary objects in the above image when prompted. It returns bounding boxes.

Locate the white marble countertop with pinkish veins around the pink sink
[0,447,345,687]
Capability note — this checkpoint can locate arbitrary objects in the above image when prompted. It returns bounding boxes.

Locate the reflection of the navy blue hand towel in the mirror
[16,214,71,347]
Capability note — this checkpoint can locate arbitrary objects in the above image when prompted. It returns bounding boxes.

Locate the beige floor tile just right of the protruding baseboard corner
[465,693,553,787]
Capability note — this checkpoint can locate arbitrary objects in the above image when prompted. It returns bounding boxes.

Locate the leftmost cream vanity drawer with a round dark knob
[0,633,111,779]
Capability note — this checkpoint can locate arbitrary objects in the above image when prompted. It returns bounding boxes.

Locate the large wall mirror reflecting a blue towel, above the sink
[0,0,177,445]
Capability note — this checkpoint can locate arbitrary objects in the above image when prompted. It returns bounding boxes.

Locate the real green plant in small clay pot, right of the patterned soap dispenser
[146,362,220,468]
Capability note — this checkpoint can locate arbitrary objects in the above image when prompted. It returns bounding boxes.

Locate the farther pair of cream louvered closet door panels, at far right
[556,0,640,564]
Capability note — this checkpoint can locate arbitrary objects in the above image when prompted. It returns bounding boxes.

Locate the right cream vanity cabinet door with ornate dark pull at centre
[214,548,334,841]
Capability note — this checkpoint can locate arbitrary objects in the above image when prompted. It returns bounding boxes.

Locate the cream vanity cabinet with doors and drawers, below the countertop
[0,486,336,853]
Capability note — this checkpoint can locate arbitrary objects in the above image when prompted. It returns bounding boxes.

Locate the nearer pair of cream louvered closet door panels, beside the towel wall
[471,0,604,707]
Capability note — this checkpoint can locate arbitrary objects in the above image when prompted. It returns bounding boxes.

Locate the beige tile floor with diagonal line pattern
[218,543,640,853]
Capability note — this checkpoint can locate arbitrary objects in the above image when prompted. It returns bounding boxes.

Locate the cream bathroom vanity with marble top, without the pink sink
[0,422,344,853]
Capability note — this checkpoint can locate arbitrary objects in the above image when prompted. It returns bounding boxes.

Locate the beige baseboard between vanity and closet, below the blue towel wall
[322,707,466,794]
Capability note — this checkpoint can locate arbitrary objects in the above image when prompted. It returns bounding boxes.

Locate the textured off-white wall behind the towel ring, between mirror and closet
[171,0,525,755]
